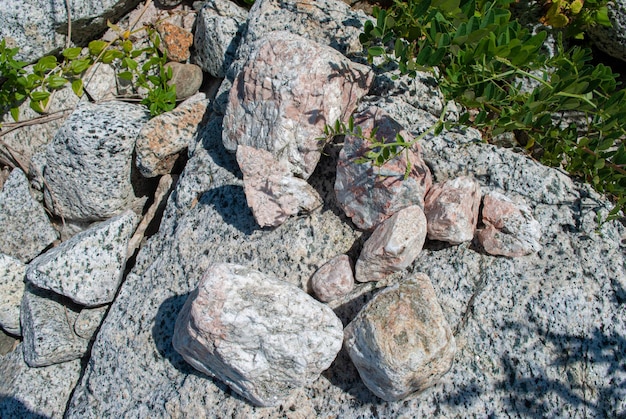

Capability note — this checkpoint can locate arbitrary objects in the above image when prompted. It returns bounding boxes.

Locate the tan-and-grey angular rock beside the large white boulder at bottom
[345,274,456,401]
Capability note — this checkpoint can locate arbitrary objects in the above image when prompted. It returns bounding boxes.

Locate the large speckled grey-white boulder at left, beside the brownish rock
[44,102,148,221]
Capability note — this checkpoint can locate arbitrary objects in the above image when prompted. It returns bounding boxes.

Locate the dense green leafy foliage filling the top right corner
[361,0,626,223]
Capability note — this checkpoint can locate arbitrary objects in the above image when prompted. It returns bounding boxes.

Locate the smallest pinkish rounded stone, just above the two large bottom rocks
[311,255,354,302]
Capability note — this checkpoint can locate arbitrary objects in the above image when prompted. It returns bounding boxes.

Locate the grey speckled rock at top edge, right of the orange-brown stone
[194,0,248,77]
